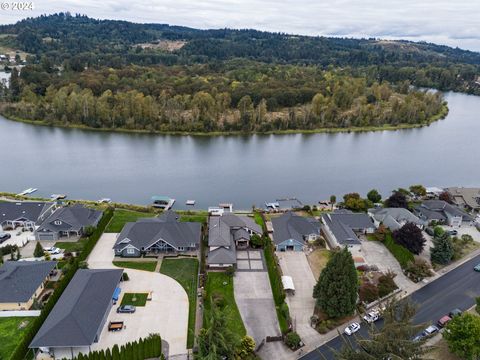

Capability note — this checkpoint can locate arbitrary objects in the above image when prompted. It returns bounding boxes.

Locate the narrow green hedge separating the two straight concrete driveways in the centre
[263,236,290,333]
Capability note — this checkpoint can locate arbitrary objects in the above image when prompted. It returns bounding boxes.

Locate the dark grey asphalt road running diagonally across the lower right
[301,255,480,360]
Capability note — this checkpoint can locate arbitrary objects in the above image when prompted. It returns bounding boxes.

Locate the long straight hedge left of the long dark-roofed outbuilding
[9,209,113,360]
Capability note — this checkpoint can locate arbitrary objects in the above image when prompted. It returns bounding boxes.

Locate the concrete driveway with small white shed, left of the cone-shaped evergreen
[276,251,321,346]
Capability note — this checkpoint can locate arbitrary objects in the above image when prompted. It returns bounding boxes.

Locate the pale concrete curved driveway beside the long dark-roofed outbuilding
[87,233,188,355]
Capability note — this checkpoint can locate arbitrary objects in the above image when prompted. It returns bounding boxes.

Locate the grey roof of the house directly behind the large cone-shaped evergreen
[322,211,374,245]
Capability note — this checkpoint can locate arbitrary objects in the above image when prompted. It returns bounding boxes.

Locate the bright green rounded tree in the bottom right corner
[443,313,480,360]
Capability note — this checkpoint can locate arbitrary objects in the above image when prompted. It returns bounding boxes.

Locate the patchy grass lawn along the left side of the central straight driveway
[204,272,247,337]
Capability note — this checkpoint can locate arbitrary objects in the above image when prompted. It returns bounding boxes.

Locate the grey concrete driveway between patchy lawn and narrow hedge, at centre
[233,271,290,359]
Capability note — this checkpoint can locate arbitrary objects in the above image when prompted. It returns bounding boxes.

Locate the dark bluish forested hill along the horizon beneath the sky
[0,13,480,66]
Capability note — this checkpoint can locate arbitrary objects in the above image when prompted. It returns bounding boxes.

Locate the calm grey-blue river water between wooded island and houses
[0,93,480,209]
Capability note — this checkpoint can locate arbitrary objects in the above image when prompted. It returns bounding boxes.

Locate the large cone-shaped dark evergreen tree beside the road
[313,247,358,318]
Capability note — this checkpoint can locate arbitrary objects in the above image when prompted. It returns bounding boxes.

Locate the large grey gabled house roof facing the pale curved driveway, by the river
[113,210,202,250]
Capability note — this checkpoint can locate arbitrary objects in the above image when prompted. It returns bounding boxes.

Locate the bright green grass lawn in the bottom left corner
[0,317,35,359]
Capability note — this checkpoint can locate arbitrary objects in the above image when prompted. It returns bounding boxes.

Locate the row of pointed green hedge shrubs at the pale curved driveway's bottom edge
[70,334,162,360]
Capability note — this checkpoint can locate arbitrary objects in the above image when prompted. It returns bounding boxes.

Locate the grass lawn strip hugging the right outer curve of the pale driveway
[160,258,198,349]
